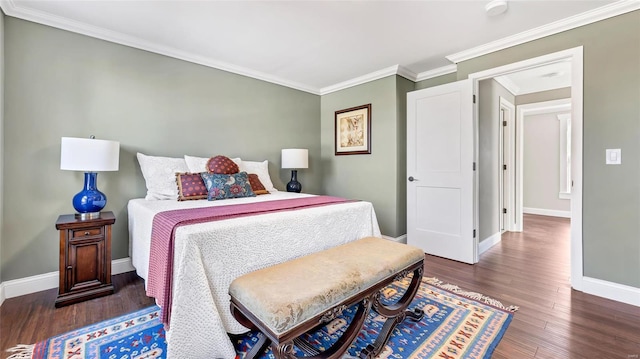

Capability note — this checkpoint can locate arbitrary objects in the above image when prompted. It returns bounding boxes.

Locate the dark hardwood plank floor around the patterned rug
[0,215,640,359]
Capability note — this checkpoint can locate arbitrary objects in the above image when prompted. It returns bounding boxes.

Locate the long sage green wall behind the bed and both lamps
[1,17,320,281]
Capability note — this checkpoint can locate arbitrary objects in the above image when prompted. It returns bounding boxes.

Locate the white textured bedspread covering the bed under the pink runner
[128,192,380,359]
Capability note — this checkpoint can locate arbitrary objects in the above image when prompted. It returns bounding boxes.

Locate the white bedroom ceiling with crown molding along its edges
[0,0,639,94]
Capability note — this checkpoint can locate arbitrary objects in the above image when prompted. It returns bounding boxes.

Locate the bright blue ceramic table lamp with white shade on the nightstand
[60,136,120,220]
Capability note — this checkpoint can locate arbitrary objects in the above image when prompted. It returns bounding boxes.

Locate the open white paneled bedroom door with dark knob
[407,80,477,263]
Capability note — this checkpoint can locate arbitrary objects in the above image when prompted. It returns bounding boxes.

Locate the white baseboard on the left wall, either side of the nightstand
[0,258,135,305]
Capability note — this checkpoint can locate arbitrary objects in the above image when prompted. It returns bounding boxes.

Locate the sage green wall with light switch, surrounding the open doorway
[416,11,640,288]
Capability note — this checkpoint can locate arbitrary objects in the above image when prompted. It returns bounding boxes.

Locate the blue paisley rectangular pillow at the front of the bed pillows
[201,172,256,201]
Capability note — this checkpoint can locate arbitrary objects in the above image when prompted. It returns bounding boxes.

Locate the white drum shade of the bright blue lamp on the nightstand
[60,137,120,172]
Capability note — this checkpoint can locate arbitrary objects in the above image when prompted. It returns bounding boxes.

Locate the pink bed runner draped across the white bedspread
[147,196,350,327]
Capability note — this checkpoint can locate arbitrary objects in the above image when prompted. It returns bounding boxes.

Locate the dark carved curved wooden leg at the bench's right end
[360,267,424,359]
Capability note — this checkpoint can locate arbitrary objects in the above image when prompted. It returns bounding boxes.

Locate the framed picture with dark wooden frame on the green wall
[335,104,371,156]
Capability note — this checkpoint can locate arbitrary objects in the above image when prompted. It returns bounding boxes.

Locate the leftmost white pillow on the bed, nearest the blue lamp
[137,152,189,200]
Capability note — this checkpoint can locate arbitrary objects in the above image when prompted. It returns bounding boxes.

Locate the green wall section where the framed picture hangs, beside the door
[321,75,413,237]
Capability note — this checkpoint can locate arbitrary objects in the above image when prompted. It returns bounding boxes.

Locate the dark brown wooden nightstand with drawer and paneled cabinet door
[56,212,116,307]
